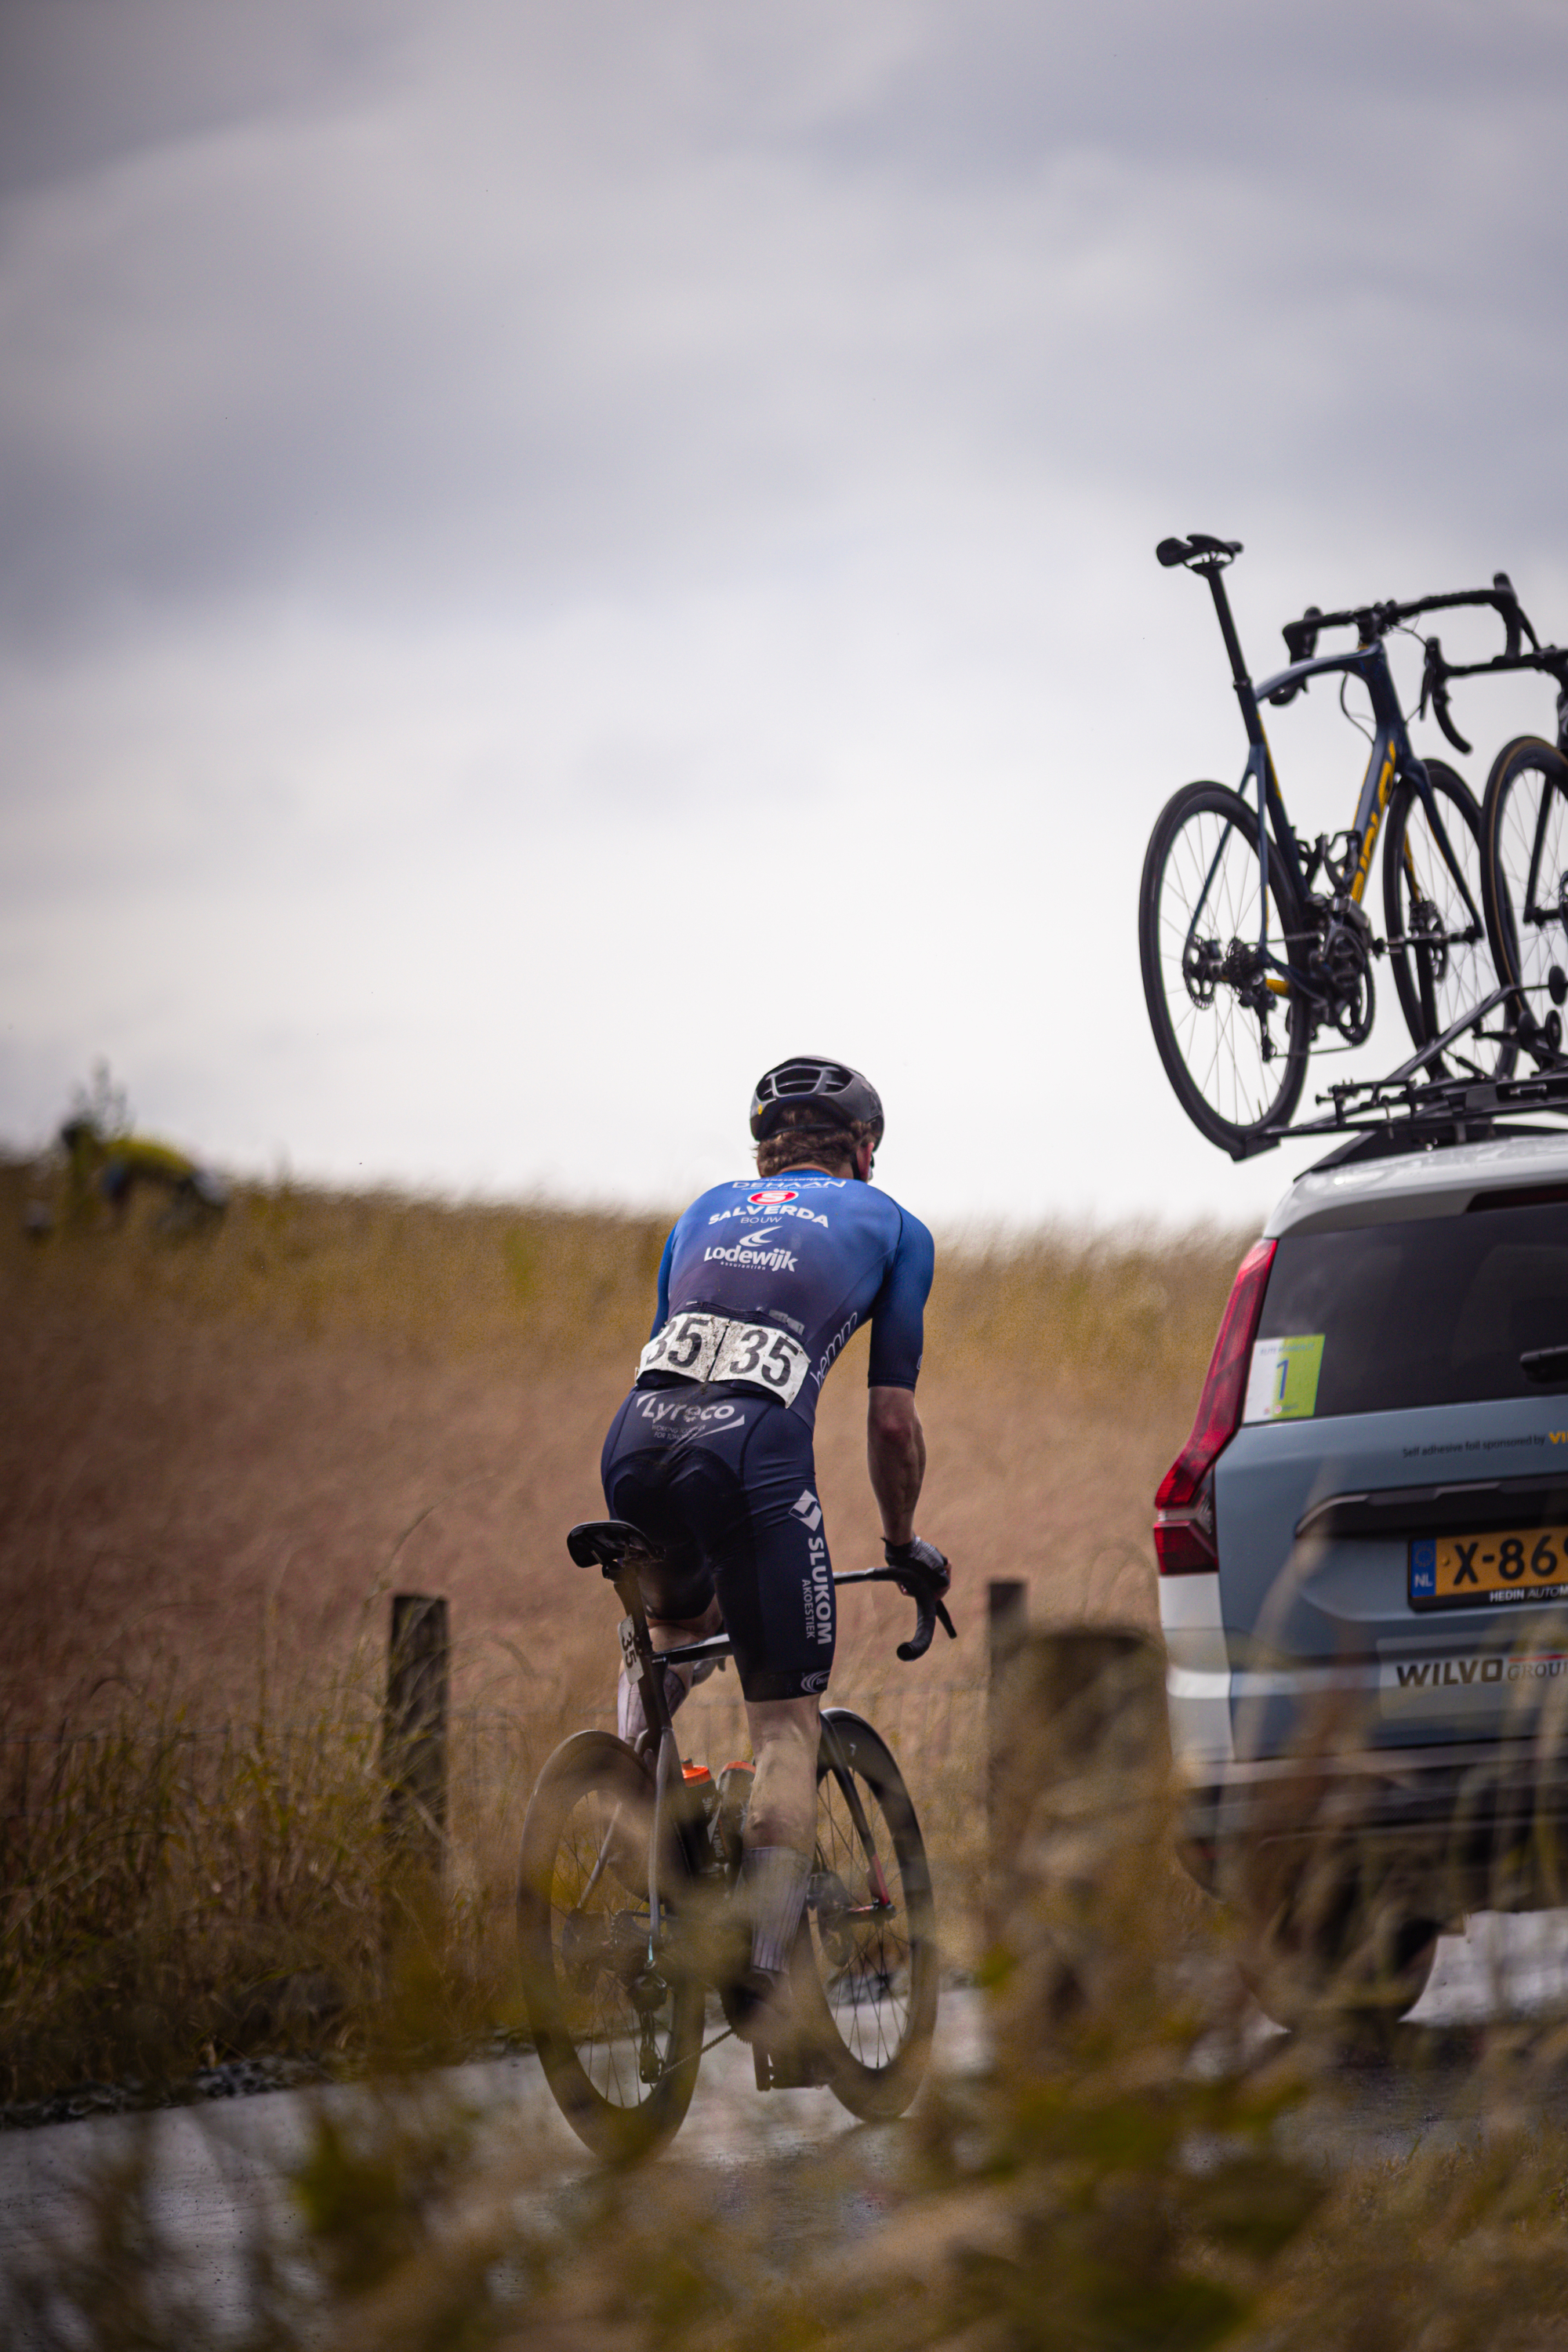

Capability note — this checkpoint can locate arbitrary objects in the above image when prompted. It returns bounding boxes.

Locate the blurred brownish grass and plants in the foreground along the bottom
[18,1661,1568,2352]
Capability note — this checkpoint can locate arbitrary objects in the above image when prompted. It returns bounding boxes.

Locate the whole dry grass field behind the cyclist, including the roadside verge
[0,1167,1236,2100]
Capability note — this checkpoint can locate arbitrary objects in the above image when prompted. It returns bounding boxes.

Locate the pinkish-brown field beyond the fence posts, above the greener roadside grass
[0,1167,1241,1736]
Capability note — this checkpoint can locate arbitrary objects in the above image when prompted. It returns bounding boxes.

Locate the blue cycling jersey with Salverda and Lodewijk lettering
[654,1169,935,1425]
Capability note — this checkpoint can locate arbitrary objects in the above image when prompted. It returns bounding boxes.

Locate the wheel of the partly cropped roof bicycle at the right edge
[1481,736,1568,1021]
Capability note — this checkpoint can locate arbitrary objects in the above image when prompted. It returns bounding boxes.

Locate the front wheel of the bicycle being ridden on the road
[794,1708,938,2122]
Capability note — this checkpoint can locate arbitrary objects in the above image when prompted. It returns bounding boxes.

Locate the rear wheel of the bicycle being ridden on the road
[517,1731,706,2161]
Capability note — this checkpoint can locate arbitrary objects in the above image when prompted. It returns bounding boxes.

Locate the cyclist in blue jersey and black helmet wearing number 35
[602,1054,947,2044]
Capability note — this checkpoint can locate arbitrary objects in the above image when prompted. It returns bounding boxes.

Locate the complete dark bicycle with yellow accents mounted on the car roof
[1138,532,1523,1160]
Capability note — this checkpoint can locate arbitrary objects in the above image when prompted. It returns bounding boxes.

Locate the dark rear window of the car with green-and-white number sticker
[1246,1200,1568,1421]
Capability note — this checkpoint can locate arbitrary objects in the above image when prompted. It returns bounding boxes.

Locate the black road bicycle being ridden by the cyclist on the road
[517,1519,952,2161]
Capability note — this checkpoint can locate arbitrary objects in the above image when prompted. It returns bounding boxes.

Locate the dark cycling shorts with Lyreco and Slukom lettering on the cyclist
[600,1374,834,1698]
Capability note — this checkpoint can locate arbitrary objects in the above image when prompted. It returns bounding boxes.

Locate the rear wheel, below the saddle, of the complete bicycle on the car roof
[1138,783,1312,1160]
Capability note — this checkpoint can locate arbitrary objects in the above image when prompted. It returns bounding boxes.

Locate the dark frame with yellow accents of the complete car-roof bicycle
[1187,560,1486,1002]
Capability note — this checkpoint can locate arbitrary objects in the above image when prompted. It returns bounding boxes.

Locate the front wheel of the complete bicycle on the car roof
[1382,760,1516,1077]
